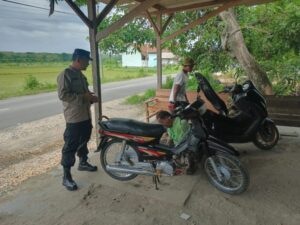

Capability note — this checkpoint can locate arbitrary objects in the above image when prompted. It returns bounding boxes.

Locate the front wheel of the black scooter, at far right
[253,121,279,150]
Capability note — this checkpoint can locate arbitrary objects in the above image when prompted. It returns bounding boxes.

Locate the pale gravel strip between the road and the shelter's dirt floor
[0,99,144,197]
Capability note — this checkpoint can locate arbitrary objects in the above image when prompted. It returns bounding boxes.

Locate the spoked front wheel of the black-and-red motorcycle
[204,154,250,194]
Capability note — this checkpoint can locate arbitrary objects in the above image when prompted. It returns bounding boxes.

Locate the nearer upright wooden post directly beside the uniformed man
[87,0,102,146]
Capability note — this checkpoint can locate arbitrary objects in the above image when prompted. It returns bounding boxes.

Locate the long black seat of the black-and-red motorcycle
[99,118,166,138]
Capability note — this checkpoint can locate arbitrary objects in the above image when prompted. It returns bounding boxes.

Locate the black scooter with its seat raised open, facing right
[195,73,279,150]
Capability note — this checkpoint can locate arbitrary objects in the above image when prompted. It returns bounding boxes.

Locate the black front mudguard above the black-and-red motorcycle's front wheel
[207,136,240,156]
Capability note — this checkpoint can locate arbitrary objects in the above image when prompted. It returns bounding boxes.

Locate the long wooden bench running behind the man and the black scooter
[145,89,300,127]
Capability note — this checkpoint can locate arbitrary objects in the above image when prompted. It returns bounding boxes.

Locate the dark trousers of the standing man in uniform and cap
[61,120,93,168]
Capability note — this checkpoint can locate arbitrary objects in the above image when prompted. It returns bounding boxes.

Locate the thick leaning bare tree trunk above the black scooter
[220,9,273,95]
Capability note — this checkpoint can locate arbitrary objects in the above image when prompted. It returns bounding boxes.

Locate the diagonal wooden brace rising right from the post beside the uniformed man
[96,0,160,42]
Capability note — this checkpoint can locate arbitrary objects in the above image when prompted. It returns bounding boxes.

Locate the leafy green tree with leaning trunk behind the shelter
[49,0,300,94]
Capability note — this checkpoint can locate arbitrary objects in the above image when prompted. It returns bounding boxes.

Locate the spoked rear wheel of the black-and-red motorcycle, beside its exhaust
[100,140,139,181]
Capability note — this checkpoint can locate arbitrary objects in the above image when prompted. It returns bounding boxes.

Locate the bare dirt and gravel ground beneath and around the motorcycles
[0,100,300,225]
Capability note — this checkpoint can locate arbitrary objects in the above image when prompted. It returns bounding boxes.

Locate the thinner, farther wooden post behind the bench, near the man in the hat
[156,13,162,89]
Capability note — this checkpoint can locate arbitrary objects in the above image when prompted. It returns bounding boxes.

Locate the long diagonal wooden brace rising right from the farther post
[161,0,244,44]
